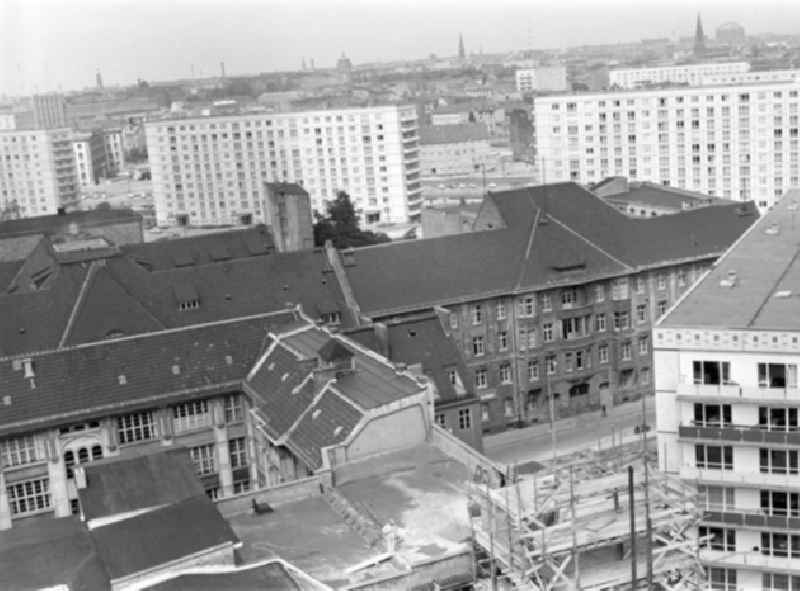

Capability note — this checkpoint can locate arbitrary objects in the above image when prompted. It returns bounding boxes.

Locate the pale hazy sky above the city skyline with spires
[0,0,800,95]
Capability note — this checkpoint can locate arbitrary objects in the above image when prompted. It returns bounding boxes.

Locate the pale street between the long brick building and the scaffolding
[483,397,655,464]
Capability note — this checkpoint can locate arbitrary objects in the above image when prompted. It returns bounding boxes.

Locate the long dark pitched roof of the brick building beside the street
[345,183,757,317]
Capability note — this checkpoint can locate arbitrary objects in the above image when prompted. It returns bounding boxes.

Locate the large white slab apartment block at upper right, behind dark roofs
[533,82,800,210]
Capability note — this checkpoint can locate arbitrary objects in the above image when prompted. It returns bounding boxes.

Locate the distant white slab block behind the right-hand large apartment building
[608,62,750,89]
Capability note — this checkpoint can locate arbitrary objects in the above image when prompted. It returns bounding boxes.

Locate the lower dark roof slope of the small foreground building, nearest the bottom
[90,494,238,580]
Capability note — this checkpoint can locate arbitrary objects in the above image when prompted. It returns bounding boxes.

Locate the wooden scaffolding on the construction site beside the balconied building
[469,445,705,591]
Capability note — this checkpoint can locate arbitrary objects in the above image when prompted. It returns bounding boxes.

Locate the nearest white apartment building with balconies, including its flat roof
[653,191,800,591]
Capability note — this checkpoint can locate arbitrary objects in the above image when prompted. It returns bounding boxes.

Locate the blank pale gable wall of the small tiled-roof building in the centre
[347,405,426,462]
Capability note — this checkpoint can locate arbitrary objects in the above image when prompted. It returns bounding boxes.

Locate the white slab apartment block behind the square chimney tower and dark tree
[145,106,422,226]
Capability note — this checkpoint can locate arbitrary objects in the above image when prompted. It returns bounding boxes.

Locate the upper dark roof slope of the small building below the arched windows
[78,447,204,520]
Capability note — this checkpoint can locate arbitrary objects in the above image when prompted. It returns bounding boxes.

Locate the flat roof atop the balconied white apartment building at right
[658,189,800,331]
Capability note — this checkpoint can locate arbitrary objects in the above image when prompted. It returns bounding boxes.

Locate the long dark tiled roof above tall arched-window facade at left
[0,312,295,433]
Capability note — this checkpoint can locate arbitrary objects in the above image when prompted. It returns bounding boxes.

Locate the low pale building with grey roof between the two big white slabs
[419,123,497,176]
